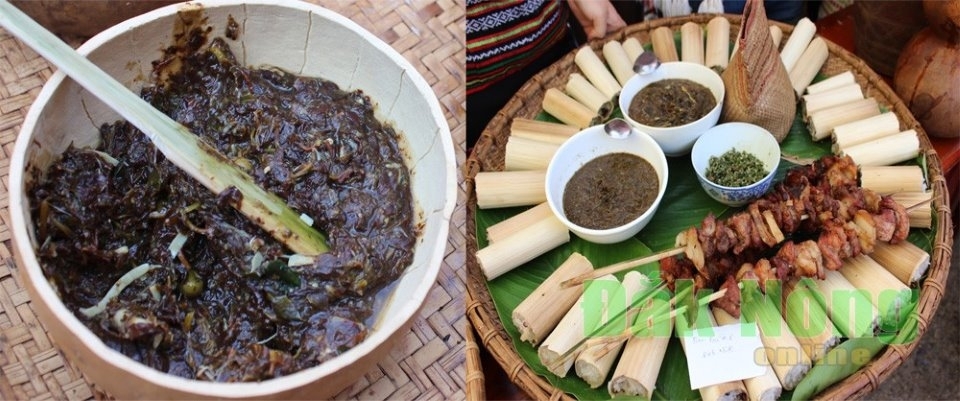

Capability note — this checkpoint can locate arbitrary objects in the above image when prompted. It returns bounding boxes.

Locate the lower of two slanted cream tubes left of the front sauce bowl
[476,216,570,280]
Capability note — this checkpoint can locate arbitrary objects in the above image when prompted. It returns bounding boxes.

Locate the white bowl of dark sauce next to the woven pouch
[619,61,726,156]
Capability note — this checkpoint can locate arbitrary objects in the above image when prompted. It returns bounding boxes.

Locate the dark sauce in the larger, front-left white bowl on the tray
[563,152,660,230]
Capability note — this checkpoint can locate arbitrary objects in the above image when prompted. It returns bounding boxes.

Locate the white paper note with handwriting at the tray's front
[684,323,766,390]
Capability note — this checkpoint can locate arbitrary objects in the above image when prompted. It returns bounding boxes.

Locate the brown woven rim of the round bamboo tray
[464,15,953,399]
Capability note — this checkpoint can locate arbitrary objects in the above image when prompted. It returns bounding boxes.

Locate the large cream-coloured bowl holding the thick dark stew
[8,0,457,399]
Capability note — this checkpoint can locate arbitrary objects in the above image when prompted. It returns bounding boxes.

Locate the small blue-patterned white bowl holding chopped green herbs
[690,122,780,206]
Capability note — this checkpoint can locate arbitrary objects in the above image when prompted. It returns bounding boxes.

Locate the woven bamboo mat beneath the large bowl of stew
[0,0,467,400]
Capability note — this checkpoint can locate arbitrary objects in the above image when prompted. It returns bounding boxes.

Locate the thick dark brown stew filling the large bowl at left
[28,38,420,382]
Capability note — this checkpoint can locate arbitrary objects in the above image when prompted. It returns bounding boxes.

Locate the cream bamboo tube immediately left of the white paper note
[607,284,673,399]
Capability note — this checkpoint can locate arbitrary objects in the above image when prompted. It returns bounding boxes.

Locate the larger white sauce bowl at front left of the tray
[545,125,668,244]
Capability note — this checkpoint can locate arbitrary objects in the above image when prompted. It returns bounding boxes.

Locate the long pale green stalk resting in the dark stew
[0,1,327,255]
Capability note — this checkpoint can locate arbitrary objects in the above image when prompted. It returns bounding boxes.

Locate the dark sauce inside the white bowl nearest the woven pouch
[628,78,717,127]
